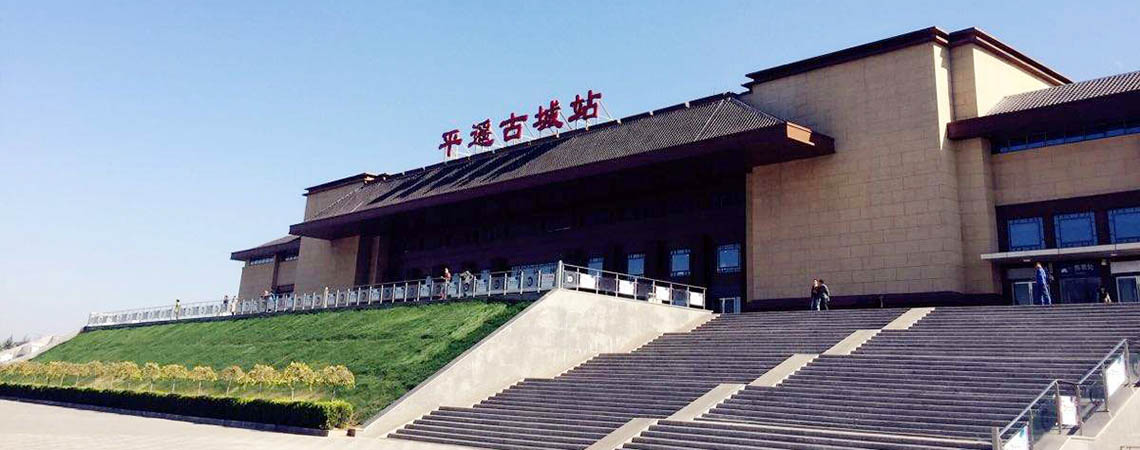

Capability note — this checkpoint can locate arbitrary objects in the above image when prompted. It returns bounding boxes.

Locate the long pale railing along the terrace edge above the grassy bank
[87,262,705,327]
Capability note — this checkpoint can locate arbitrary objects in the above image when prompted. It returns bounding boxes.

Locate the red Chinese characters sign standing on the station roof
[439,90,602,158]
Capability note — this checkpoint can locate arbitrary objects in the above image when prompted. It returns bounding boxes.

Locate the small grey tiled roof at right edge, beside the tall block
[986,71,1140,116]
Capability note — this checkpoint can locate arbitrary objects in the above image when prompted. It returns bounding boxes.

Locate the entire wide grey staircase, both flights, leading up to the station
[390,304,1140,450]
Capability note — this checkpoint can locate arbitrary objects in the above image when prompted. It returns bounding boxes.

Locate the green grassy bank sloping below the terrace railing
[35,302,529,422]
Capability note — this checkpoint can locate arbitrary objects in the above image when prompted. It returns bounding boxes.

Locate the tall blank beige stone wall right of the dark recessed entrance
[744,43,962,298]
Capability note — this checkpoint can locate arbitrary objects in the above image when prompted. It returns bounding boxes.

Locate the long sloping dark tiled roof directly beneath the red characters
[311,93,785,220]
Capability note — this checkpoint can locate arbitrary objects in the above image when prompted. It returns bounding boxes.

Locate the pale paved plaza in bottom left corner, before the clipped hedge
[0,400,458,450]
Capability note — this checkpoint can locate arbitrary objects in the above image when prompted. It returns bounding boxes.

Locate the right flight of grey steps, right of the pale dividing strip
[688,305,1140,448]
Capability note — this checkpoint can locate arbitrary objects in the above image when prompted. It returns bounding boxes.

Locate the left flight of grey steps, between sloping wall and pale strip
[389,310,904,449]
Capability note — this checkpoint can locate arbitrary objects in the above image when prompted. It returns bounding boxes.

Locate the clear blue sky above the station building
[0,0,1140,338]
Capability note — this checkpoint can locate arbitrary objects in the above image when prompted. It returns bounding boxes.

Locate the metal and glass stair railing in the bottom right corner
[993,338,1140,450]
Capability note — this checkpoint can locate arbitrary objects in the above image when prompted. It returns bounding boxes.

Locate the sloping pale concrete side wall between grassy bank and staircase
[363,289,713,436]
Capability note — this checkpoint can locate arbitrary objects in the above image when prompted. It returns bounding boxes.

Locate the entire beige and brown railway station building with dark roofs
[231,27,1140,310]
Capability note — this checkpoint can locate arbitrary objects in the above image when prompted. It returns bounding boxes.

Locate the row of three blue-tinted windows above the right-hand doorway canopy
[1007,207,1140,252]
